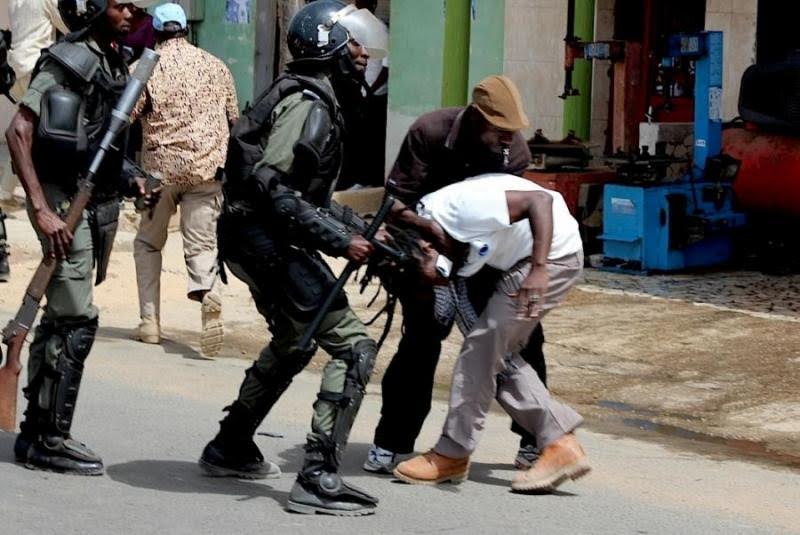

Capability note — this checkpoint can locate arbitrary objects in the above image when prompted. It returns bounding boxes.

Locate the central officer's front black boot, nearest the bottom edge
[286,451,378,516]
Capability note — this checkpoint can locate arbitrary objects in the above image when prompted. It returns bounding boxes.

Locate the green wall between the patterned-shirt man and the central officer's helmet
[196,0,256,107]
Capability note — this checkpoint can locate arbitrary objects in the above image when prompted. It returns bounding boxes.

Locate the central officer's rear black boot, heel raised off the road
[199,401,281,479]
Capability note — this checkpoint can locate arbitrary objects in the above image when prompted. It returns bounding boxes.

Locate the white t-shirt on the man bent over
[417,173,583,277]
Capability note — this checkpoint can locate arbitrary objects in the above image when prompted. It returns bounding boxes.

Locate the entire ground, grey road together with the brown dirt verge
[0,195,800,533]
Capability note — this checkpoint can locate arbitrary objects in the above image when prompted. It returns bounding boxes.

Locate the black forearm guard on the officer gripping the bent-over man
[271,186,351,256]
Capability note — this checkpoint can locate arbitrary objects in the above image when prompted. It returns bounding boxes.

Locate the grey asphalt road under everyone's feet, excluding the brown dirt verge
[0,326,800,535]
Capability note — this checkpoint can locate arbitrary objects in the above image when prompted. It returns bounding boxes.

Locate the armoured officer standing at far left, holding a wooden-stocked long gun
[6,0,153,475]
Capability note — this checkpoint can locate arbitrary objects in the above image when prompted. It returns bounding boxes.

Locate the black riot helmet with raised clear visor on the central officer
[286,0,388,75]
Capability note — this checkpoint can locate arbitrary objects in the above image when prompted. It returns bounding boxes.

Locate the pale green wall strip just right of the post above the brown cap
[467,0,506,91]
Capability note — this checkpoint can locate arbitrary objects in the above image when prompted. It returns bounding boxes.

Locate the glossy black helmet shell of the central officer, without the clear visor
[286,0,350,63]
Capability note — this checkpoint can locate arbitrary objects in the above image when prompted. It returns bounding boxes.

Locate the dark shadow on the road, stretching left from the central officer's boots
[106,460,289,505]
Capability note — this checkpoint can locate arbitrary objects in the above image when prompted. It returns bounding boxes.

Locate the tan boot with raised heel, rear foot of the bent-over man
[511,433,591,492]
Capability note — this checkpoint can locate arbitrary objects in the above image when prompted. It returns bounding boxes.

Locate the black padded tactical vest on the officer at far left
[33,38,128,198]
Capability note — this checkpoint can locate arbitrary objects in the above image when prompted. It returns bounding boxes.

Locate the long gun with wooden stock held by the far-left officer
[0,49,159,432]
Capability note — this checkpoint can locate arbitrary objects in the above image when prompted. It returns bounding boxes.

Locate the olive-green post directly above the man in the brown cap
[442,0,471,107]
